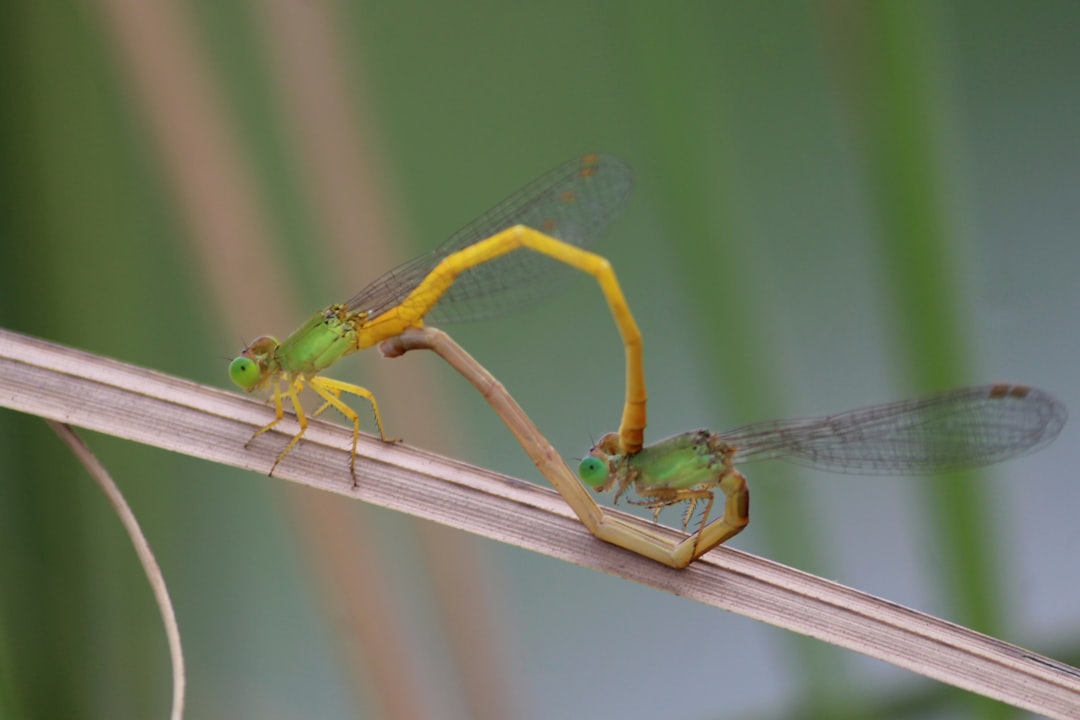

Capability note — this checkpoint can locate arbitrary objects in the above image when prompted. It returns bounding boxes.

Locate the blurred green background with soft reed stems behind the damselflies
[0,0,1080,720]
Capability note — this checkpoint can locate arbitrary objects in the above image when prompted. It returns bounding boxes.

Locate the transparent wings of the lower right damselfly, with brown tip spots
[717,385,1068,475]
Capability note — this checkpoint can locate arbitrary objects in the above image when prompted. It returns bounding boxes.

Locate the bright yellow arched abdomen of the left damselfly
[364,226,647,454]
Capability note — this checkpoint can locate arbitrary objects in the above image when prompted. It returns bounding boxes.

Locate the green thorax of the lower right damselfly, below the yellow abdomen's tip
[616,430,725,490]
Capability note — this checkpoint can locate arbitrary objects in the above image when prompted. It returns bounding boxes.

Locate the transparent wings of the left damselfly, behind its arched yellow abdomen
[346,154,633,323]
